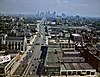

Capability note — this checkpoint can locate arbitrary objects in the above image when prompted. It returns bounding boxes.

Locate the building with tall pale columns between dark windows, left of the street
[6,36,27,51]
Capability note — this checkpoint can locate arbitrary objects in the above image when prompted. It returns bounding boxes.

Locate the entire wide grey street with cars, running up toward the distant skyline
[13,19,45,77]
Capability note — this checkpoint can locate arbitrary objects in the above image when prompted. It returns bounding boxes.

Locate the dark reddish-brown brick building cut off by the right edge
[83,45,100,72]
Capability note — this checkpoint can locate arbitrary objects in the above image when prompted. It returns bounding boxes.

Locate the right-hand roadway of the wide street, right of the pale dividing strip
[28,19,45,77]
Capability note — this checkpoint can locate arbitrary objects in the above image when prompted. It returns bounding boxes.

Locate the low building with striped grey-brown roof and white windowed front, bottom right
[60,63,96,77]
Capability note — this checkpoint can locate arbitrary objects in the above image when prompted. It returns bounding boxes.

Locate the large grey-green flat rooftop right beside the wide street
[45,48,62,67]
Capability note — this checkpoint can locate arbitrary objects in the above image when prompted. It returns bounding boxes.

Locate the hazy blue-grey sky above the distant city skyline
[0,0,100,17]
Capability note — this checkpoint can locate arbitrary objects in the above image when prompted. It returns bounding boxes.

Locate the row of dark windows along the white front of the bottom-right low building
[61,71,95,76]
